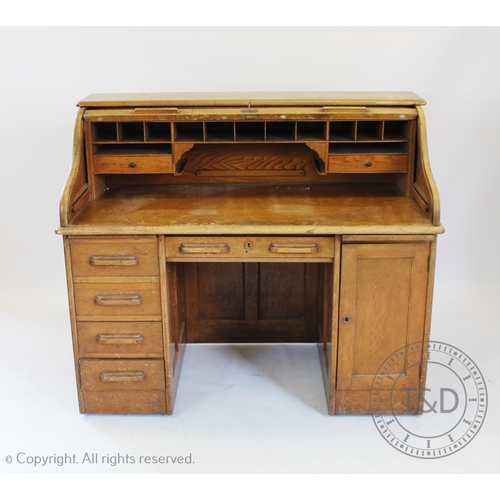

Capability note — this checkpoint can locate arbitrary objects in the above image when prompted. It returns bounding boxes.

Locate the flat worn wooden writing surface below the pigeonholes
[61,184,442,234]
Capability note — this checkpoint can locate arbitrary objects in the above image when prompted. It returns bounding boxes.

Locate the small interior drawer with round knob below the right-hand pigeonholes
[328,153,408,174]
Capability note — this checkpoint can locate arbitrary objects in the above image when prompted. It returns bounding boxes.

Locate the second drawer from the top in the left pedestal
[74,283,161,321]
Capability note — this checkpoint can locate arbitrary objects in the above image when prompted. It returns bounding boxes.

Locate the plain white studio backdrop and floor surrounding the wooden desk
[0,27,500,473]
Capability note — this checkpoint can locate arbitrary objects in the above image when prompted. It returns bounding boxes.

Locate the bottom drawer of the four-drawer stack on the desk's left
[80,359,166,414]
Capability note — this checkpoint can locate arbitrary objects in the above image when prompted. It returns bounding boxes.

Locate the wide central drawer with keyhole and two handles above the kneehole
[165,236,334,262]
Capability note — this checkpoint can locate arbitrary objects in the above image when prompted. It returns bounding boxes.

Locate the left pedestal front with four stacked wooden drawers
[68,236,166,413]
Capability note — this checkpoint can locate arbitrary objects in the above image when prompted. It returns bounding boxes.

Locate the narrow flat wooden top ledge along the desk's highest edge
[78,92,425,108]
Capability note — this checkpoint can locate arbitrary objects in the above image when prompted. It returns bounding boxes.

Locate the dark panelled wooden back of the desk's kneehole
[184,263,320,343]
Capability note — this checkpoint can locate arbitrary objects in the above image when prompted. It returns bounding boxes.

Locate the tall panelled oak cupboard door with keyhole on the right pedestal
[337,242,430,390]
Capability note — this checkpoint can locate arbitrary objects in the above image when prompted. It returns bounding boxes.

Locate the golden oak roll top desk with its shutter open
[57,92,443,415]
